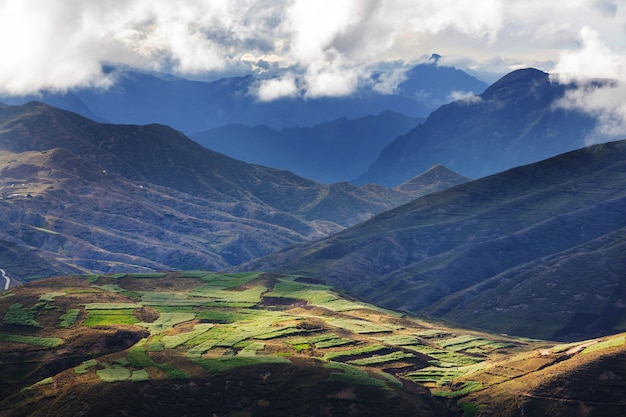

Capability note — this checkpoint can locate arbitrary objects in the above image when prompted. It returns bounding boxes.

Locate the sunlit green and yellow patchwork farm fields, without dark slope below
[0,271,625,416]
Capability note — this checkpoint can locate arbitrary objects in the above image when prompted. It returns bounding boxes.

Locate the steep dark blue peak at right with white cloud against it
[357,69,595,187]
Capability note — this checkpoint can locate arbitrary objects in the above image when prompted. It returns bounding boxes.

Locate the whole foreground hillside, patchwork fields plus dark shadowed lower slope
[0,271,626,417]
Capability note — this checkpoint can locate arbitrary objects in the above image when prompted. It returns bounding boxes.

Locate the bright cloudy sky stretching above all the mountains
[0,0,626,137]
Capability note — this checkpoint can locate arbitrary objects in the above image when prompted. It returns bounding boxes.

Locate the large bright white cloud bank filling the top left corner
[0,0,281,94]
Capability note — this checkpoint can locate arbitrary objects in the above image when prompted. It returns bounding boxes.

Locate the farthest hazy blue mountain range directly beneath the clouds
[0,64,486,134]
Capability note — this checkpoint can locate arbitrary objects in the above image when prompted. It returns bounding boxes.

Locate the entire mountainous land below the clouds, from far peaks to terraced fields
[0,62,626,417]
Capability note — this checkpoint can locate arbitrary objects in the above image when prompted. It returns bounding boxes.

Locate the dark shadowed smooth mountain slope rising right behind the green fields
[242,141,626,340]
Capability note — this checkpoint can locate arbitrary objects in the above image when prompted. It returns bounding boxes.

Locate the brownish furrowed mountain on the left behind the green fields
[0,102,420,280]
